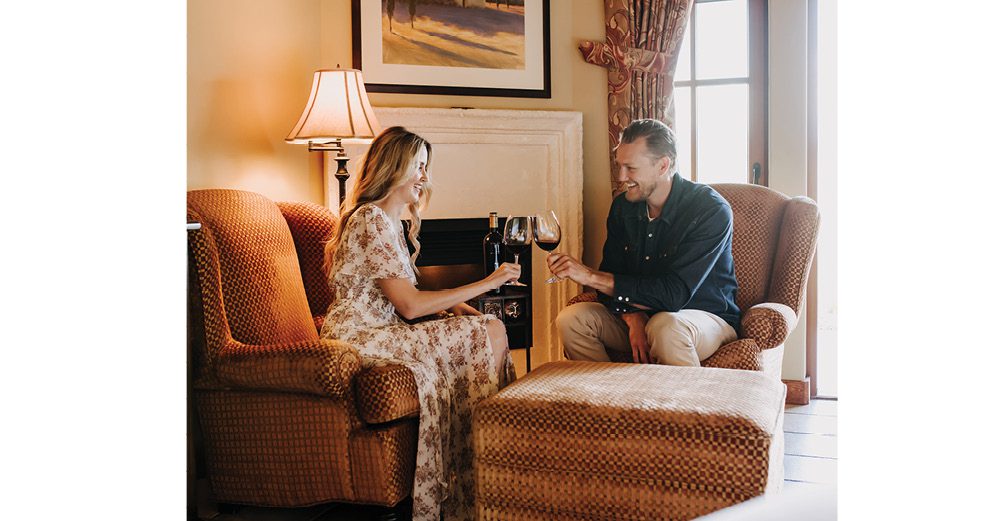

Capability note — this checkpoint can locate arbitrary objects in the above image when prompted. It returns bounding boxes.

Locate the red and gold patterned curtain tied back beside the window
[579,0,692,196]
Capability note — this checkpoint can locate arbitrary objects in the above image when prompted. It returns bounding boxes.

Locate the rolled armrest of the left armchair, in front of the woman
[214,340,360,398]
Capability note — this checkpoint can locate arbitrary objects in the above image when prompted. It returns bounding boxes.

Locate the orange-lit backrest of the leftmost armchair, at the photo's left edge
[187,190,318,350]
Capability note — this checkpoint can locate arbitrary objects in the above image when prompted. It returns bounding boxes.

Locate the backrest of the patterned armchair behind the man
[711,183,819,315]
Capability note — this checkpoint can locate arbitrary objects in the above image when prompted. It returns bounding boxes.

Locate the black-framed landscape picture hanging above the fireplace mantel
[353,0,551,98]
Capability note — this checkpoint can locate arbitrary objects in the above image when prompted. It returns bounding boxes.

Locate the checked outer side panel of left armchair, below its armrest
[195,390,357,507]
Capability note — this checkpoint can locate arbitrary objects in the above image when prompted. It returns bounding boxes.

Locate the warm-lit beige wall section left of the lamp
[188,0,322,201]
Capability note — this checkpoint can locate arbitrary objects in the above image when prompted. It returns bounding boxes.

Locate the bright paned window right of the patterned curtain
[674,0,767,185]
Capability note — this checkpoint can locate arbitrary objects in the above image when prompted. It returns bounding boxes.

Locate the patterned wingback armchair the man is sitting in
[569,183,819,380]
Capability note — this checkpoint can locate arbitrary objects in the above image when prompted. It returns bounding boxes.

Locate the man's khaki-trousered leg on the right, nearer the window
[647,309,736,366]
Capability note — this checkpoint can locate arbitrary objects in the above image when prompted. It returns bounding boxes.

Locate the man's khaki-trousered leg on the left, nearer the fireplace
[555,302,630,362]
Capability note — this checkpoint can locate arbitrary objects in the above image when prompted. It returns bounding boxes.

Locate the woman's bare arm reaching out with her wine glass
[377,262,520,320]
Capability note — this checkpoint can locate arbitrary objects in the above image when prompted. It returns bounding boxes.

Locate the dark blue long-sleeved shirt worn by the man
[599,173,740,332]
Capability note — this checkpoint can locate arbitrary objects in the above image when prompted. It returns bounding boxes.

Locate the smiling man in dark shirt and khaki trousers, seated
[548,119,739,366]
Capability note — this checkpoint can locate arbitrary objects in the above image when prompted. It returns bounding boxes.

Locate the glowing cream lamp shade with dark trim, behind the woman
[284,69,380,143]
